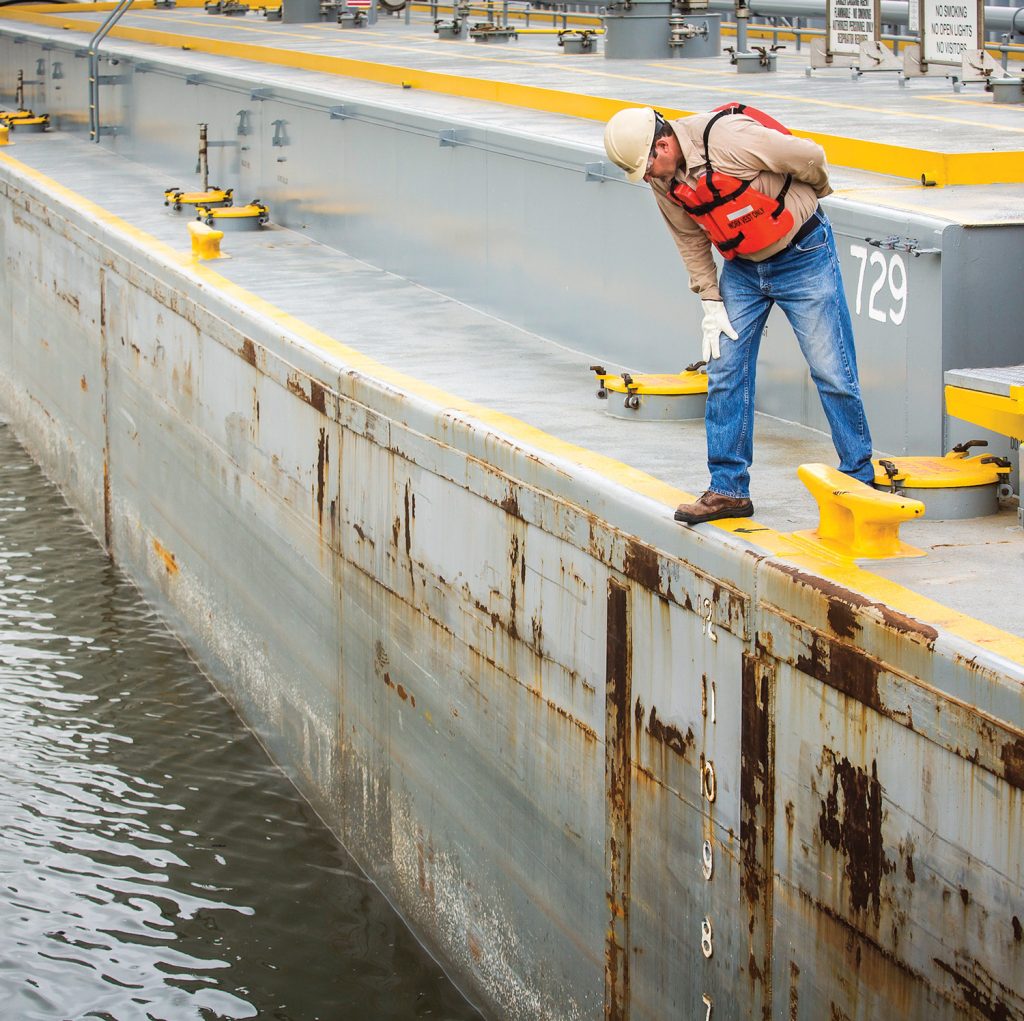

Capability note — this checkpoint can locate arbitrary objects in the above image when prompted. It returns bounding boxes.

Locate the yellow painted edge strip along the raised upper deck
[2,8,1024,186]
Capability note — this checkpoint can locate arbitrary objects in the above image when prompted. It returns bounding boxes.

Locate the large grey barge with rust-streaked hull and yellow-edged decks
[0,5,1024,1021]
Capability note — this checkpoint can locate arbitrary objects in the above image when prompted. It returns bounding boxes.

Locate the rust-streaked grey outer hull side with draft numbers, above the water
[0,151,1024,1021]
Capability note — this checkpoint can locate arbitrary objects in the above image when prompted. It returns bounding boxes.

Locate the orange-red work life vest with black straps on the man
[669,102,793,259]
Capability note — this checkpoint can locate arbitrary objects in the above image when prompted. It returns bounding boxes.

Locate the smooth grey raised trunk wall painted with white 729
[0,24,1024,462]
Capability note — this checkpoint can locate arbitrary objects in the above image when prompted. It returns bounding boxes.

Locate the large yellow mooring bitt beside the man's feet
[793,464,925,560]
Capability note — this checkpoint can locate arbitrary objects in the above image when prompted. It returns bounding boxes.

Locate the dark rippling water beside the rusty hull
[0,424,478,1021]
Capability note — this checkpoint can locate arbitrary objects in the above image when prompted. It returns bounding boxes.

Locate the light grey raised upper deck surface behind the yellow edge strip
[6,7,1024,179]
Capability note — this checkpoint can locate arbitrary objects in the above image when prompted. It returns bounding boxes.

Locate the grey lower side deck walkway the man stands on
[5,134,1024,636]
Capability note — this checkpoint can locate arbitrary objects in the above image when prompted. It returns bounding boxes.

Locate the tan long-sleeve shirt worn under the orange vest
[650,114,831,300]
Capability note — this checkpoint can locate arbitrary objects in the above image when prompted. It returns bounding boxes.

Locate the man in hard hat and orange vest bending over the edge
[604,104,874,524]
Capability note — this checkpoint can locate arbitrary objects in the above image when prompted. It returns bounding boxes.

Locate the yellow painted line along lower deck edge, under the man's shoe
[0,153,1024,666]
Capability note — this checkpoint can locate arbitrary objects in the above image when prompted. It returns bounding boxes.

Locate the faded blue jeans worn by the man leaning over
[705,210,874,497]
